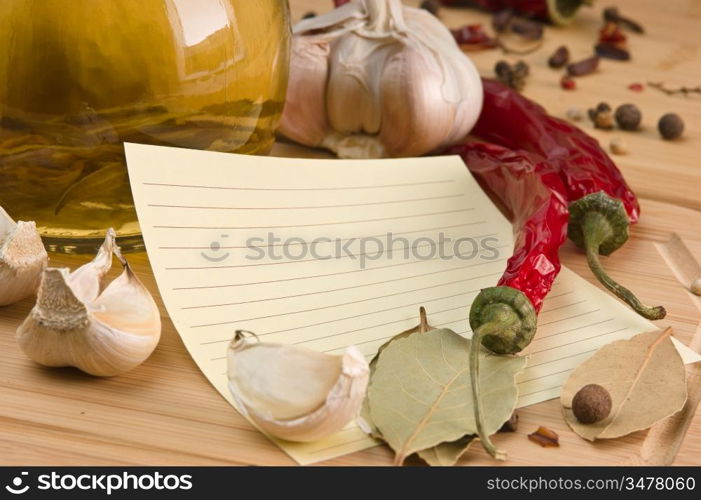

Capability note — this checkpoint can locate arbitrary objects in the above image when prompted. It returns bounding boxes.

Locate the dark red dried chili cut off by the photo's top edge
[440,0,589,24]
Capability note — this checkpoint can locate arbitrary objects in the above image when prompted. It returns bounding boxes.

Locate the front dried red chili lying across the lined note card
[447,143,569,458]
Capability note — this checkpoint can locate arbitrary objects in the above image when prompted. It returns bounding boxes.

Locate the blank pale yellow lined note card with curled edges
[125,144,691,464]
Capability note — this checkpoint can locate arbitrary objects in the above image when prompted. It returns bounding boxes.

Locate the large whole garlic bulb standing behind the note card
[280,0,482,158]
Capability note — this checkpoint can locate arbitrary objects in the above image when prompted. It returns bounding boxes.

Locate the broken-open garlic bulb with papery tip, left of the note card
[17,229,161,377]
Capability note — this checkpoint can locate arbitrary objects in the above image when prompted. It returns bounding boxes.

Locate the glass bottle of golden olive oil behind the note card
[0,0,290,252]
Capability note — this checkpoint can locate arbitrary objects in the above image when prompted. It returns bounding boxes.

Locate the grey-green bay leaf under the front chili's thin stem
[367,329,526,465]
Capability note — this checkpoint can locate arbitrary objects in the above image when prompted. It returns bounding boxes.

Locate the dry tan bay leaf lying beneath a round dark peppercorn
[561,328,687,441]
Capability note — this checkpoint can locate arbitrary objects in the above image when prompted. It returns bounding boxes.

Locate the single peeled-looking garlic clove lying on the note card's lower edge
[228,332,370,442]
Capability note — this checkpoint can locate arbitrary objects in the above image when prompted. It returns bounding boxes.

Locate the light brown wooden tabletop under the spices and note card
[0,0,701,465]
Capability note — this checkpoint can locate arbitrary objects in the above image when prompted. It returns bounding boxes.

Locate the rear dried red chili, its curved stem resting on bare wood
[472,79,666,319]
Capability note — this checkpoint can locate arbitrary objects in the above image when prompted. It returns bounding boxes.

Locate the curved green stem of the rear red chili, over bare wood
[581,211,667,320]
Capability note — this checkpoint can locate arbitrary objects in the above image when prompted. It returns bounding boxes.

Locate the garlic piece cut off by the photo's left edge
[0,207,49,306]
